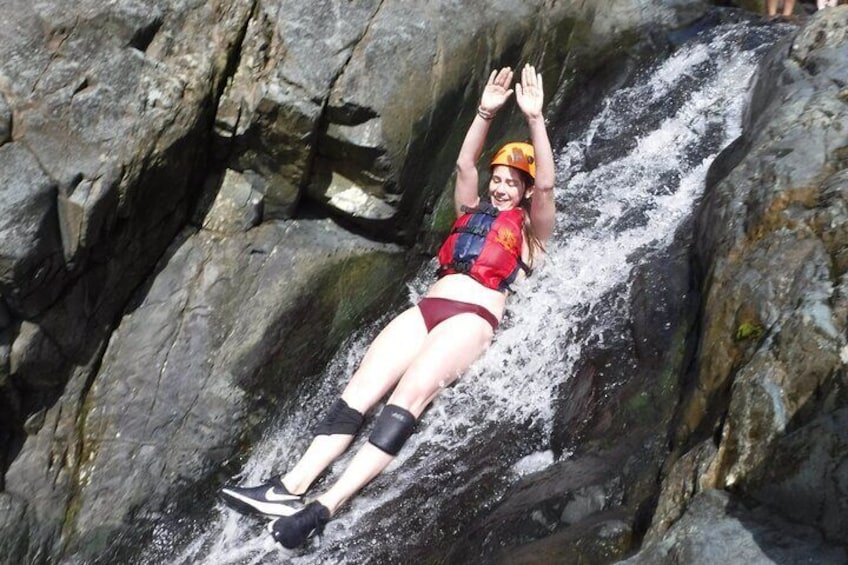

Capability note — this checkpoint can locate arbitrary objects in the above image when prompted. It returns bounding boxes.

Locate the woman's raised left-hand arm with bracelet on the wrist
[453,67,512,216]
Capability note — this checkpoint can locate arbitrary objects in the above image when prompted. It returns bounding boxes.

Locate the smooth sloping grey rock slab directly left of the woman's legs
[53,221,403,556]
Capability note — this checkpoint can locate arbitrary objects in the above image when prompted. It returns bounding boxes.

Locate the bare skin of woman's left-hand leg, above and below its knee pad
[282,306,427,494]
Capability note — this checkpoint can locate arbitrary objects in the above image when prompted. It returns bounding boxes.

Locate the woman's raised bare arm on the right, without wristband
[515,65,556,243]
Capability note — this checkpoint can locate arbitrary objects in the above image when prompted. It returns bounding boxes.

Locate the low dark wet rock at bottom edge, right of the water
[445,434,662,563]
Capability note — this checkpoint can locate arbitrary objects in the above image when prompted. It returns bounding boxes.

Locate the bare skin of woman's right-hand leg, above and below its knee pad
[317,314,493,515]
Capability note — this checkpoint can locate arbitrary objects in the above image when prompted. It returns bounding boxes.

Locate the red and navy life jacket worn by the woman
[438,202,530,291]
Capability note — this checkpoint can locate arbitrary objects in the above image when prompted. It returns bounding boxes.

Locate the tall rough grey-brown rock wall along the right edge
[634,6,848,563]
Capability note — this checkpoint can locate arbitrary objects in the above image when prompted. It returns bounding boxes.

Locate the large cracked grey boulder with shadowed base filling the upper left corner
[0,0,250,480]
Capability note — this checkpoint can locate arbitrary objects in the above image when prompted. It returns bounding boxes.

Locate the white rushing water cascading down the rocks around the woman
[144,15,786,564]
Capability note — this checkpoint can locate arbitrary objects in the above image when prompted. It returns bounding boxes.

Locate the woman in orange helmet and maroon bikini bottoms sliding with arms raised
[221,65,554,549]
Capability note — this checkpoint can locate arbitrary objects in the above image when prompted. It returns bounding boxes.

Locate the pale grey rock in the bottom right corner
[621,490,848,565]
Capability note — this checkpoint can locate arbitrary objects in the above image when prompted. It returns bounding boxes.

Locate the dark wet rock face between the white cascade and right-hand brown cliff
[552,218,697,452]
